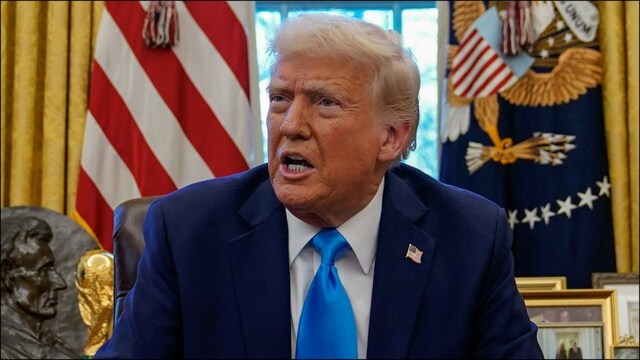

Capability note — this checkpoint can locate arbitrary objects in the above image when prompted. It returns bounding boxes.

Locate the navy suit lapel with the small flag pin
[367,173,435,359]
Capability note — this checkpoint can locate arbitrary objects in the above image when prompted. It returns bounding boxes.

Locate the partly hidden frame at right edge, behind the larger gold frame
[591,273,640,343]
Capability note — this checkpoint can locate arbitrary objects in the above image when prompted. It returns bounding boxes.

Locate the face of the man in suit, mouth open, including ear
[267,56,408,227]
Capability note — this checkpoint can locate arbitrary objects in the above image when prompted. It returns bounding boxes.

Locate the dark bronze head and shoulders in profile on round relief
[1,217,80,359]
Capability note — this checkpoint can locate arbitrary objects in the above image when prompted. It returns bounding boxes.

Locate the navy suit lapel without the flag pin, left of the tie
[229,181,291,358]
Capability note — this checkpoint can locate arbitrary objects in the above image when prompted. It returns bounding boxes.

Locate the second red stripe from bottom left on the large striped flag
[89,62,176,196]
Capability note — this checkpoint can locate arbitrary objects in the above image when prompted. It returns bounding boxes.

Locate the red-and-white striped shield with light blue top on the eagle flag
[449,7,534,98]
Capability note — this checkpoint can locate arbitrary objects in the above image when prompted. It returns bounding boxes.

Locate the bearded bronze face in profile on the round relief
[10,238,67,319]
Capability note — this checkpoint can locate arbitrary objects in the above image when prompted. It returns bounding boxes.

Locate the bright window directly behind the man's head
[256,1,438,177]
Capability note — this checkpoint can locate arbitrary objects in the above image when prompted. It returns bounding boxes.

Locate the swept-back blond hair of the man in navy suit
[269,13,420,159]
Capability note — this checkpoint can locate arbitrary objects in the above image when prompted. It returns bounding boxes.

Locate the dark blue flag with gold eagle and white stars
[440,1,616,288]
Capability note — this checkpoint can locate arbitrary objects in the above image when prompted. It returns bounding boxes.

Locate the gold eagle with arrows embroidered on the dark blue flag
[447,1,602,173]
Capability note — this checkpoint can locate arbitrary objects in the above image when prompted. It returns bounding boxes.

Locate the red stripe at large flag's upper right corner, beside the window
[184,1,251,99]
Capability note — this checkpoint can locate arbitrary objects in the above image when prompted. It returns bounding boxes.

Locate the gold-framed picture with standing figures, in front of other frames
[522,289,617,359]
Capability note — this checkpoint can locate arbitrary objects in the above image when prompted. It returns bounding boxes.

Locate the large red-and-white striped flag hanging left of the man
[74,1,262,251]
